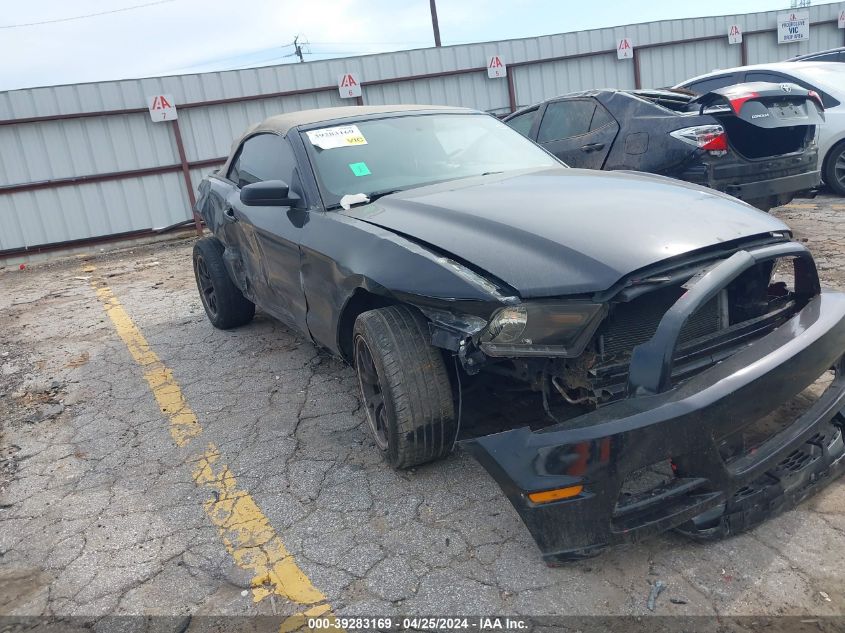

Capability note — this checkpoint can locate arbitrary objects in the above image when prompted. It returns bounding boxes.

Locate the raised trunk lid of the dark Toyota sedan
[689,81,824,128]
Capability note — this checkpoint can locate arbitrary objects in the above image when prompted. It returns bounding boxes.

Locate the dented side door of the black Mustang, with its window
[224,133,308,333]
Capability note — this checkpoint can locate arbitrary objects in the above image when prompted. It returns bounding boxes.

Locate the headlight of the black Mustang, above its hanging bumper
[481,302,606,357]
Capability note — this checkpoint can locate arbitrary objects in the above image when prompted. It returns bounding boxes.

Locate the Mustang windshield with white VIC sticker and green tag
[302,114,562,207]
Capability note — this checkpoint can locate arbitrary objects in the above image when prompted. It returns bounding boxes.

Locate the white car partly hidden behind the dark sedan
[675,62,845,196]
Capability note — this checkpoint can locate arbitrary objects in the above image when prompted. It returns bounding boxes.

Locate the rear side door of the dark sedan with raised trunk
[537,97,619,169]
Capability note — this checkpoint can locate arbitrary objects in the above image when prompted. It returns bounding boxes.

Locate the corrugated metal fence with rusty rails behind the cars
[0,3,845,257]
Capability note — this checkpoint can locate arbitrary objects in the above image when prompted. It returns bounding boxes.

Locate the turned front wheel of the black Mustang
[352,306,457,468]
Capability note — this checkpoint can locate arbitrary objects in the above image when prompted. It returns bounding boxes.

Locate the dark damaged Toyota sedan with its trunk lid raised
[504,82,824,211]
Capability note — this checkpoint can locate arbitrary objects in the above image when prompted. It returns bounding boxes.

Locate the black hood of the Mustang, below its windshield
[341,168,788,298]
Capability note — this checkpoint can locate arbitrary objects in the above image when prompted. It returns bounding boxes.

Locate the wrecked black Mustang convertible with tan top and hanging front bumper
[194,106,845,564]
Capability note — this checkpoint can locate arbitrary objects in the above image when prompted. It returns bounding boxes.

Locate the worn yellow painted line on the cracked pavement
[83,266,337,632]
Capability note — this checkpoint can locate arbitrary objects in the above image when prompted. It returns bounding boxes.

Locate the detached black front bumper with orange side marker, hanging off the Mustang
[462,243,845,563]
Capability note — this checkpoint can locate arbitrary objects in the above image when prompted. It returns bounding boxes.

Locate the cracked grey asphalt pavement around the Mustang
[0,197,845,618]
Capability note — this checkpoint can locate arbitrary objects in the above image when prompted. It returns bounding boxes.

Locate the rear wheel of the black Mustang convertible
[194,237,255,330]
